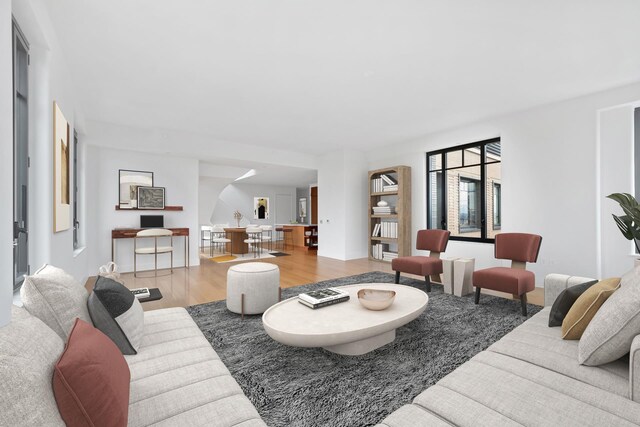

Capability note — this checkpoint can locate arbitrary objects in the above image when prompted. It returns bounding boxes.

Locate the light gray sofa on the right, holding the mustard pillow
[379,274,640,427]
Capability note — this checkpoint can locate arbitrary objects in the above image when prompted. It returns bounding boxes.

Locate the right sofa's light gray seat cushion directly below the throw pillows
[488,307,629,396]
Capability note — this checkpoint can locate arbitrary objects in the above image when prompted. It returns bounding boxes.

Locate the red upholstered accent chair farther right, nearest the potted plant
[473,233,542,316]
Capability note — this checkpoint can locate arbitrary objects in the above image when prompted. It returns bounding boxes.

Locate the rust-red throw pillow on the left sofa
[53,319,131,427]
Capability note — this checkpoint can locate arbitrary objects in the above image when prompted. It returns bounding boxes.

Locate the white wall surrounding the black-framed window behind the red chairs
[368,84,640,286]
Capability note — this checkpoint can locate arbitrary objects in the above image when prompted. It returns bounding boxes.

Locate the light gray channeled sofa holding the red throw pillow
[0,270,266,427]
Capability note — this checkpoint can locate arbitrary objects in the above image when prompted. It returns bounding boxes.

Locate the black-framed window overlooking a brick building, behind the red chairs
[427,138,502,242]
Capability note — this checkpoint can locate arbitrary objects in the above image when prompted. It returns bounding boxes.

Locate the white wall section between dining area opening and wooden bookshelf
[318,150,369,260]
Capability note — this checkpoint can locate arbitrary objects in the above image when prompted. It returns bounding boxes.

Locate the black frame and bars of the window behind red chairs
[425,137,502,243]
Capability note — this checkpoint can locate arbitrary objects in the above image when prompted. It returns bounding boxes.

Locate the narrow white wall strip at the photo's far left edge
[0,1,13,326]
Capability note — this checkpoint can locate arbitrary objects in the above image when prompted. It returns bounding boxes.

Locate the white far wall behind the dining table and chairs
[211,184,296,226]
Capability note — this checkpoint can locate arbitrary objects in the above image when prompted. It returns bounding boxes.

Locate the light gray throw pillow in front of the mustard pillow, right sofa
[578,267,640,366]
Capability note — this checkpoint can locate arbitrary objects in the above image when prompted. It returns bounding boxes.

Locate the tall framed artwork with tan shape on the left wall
[53,101,71,233]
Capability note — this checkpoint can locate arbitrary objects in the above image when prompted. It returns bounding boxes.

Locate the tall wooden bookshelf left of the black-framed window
[367,166,411,261]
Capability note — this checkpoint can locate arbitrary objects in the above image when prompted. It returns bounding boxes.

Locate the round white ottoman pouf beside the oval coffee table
[227,262,280,316]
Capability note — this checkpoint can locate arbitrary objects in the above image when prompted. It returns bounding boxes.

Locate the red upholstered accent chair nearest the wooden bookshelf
[391,230,451,292]
